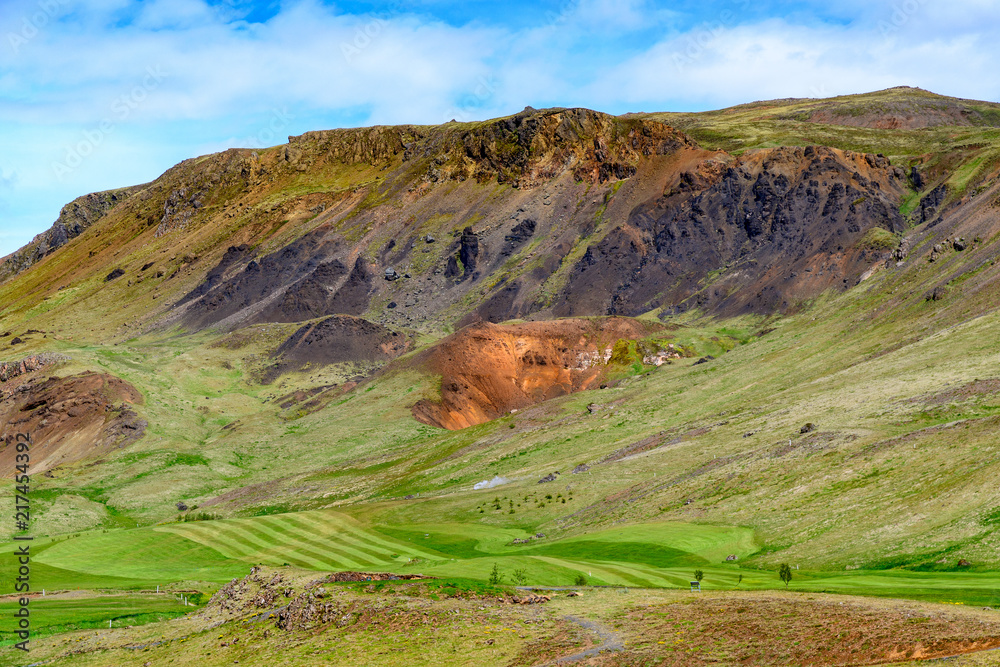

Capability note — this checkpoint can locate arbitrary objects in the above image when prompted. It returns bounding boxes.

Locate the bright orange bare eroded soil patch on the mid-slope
[413,317,662,430]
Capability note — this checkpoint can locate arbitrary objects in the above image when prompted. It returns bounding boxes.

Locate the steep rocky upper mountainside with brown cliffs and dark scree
[0,109,906,352]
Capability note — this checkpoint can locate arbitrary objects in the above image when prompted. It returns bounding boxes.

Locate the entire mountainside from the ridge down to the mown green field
[0,86,1000,582]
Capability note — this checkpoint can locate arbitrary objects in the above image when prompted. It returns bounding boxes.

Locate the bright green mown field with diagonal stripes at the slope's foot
[3,510,1000,605]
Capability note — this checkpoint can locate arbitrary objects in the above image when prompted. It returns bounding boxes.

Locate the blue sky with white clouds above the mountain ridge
[0,0,1000,256]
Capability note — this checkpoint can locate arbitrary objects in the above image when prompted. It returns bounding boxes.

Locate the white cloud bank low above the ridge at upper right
[591,20,1000,107]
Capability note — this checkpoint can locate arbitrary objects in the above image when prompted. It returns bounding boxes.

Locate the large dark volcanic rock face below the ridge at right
[553,146,904,316]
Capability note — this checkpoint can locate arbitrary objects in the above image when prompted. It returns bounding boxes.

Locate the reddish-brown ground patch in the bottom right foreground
[602,597,1000,666]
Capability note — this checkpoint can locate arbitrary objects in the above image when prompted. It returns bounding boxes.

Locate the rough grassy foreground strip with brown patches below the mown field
[7,568,1000,667]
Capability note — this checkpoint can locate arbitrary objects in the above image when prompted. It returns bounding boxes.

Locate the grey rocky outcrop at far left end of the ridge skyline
[0,185,144,281]
